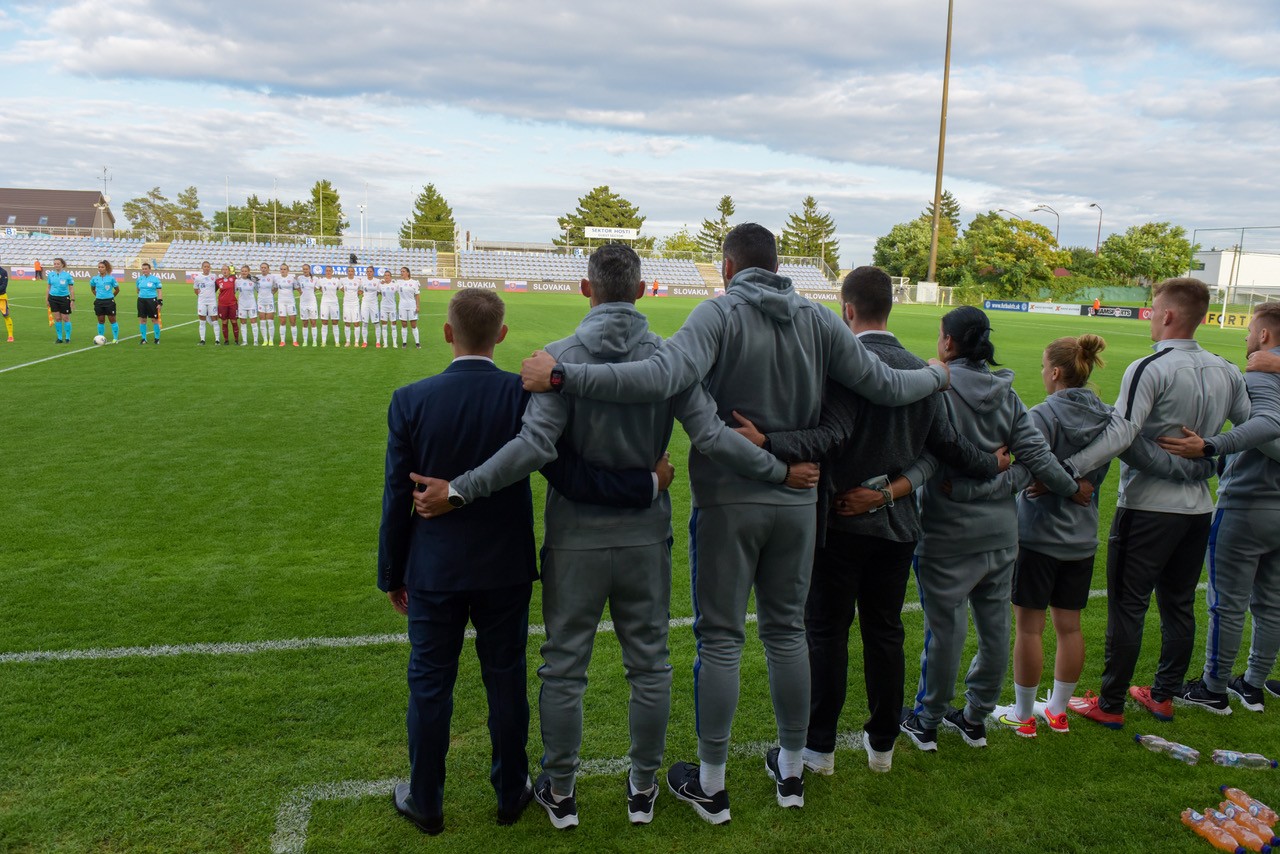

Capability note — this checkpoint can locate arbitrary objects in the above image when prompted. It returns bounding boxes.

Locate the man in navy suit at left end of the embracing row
[378,289,671,835]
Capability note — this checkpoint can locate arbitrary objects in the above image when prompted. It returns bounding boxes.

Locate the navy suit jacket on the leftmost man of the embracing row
[378,360,653,592]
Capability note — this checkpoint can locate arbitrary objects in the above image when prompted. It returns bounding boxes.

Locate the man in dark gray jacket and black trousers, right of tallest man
[739,266,1009,775]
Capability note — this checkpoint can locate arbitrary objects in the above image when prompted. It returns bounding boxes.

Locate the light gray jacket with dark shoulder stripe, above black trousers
[1068,338,1249,516]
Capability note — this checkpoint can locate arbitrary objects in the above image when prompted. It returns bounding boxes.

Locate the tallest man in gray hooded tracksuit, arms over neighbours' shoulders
[521,223,947,823]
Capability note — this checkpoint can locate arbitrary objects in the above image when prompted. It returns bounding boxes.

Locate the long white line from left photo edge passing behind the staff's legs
[0,584,1208,665]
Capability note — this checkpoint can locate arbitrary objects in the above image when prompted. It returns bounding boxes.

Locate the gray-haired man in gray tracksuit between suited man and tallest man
[416,245,817,828]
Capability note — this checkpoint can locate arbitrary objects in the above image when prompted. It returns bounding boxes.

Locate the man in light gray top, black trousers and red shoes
[1068,278,1249,729]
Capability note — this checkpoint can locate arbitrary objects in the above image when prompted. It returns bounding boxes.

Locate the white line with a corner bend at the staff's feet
[271,731,863,854]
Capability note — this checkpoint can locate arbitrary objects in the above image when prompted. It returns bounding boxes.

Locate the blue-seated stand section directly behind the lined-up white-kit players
[157,241,438,275]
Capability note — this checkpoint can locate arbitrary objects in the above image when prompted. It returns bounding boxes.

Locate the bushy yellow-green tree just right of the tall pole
[957,211,1075,300]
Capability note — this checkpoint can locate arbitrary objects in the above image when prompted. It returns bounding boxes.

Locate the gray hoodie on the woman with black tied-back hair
[915,359,1079,557]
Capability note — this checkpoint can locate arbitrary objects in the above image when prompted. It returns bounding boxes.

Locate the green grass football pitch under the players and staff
[0,282,1280,853]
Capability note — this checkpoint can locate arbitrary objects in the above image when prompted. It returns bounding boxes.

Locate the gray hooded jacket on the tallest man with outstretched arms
[563,268,946,507]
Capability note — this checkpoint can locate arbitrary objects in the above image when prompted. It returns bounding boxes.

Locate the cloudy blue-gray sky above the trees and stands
[0,0,1280,265]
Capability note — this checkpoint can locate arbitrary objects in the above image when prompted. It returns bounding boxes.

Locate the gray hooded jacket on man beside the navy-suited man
[452,302,788,549]
